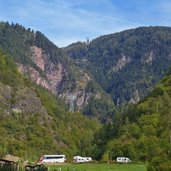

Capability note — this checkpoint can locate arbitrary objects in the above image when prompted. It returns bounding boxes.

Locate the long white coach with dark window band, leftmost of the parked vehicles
[39,155,66,163]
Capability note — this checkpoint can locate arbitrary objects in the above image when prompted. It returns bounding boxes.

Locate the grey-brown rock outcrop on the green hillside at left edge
[0,82,48,119]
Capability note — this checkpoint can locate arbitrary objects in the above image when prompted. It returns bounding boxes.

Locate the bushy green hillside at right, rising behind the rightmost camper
[93,69,171,161]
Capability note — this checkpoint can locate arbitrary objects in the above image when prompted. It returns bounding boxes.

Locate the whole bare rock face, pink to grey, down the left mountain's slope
[18,46,108,111]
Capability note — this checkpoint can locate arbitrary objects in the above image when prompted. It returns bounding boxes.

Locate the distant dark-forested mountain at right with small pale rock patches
[64,27,171,106]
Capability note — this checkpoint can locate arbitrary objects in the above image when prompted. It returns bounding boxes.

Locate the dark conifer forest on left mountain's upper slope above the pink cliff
[0,22,71,74]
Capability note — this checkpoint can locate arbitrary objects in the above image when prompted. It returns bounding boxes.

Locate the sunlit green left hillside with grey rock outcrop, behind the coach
[0,52,99,160]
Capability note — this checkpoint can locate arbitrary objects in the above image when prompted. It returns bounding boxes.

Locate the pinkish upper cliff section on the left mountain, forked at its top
[18,46,64,94]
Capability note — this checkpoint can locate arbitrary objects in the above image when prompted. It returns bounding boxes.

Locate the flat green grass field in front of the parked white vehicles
[48,163,147,171]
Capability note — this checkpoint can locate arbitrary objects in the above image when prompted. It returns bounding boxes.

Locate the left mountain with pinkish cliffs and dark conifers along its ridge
[0,22,114,120]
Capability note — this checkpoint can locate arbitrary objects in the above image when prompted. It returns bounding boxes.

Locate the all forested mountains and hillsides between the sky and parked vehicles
[0,22,171,171]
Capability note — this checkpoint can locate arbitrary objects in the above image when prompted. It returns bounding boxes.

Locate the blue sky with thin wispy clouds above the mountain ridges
[0,0,171,47]
